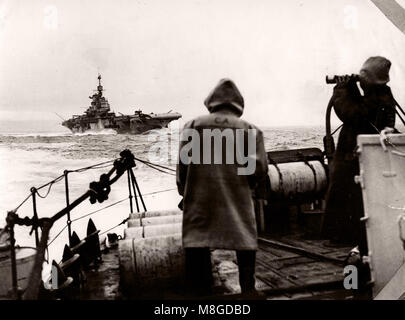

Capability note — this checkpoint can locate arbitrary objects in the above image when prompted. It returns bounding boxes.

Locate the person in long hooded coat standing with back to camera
[177,79,268,293]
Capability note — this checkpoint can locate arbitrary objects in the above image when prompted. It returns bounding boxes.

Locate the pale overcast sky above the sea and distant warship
[0,0,405,125]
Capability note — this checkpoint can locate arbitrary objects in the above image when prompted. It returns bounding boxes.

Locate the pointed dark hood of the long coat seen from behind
[204,79,244,117]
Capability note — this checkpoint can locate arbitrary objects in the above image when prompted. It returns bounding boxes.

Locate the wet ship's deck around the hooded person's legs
[80,234,353,300]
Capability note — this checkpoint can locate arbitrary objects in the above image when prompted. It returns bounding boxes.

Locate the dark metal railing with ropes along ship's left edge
[2,150,150,300]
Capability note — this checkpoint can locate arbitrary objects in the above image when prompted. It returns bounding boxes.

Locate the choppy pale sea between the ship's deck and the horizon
[0,122,324,278]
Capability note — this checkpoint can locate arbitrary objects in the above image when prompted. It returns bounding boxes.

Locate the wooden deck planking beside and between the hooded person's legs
[80,231,348,300]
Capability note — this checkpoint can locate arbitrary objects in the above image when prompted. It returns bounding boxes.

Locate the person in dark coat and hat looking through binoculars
[323,56,395,255]
